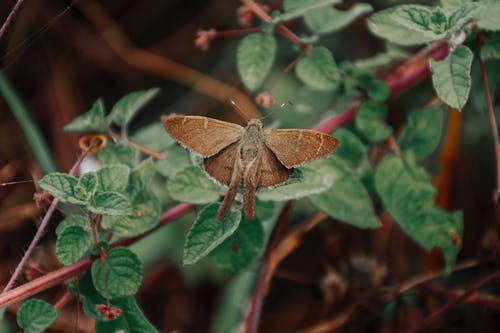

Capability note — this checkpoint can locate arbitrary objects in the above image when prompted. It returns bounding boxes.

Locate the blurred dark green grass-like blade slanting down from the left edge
[0,72,57,173]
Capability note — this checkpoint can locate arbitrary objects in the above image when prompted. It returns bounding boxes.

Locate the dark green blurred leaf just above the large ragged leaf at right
[398,108,443,160]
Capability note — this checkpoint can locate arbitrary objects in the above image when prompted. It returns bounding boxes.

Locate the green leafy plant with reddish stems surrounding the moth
[0,0,500,332]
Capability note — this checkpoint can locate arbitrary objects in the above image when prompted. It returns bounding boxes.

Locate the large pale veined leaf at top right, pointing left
[367,5,446,46]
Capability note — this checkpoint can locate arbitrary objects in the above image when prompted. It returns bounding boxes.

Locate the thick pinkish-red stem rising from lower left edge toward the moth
[0,203,194,308]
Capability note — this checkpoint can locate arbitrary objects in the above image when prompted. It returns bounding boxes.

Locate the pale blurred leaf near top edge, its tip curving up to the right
[304,3,373,35]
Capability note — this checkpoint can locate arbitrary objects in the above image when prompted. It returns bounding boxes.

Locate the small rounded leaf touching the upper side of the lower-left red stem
[56,225,92,266]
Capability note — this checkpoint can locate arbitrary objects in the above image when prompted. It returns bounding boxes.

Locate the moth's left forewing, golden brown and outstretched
[161,115,244,157]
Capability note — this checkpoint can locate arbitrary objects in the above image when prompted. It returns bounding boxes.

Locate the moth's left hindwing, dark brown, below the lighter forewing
[203,142,238,186]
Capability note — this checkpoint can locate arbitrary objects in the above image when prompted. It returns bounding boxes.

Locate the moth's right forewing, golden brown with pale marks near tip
[265,129,339,168]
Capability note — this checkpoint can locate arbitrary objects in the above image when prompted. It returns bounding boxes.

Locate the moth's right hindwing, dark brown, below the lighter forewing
[259,147,293,187]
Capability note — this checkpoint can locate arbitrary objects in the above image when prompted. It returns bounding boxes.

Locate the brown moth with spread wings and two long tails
[161,115,339,220]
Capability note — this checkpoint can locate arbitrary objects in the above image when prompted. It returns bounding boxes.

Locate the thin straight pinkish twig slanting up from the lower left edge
[0,147,92,295]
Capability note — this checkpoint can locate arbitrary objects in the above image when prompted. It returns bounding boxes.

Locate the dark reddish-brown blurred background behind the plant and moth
[0,0,500,332]
